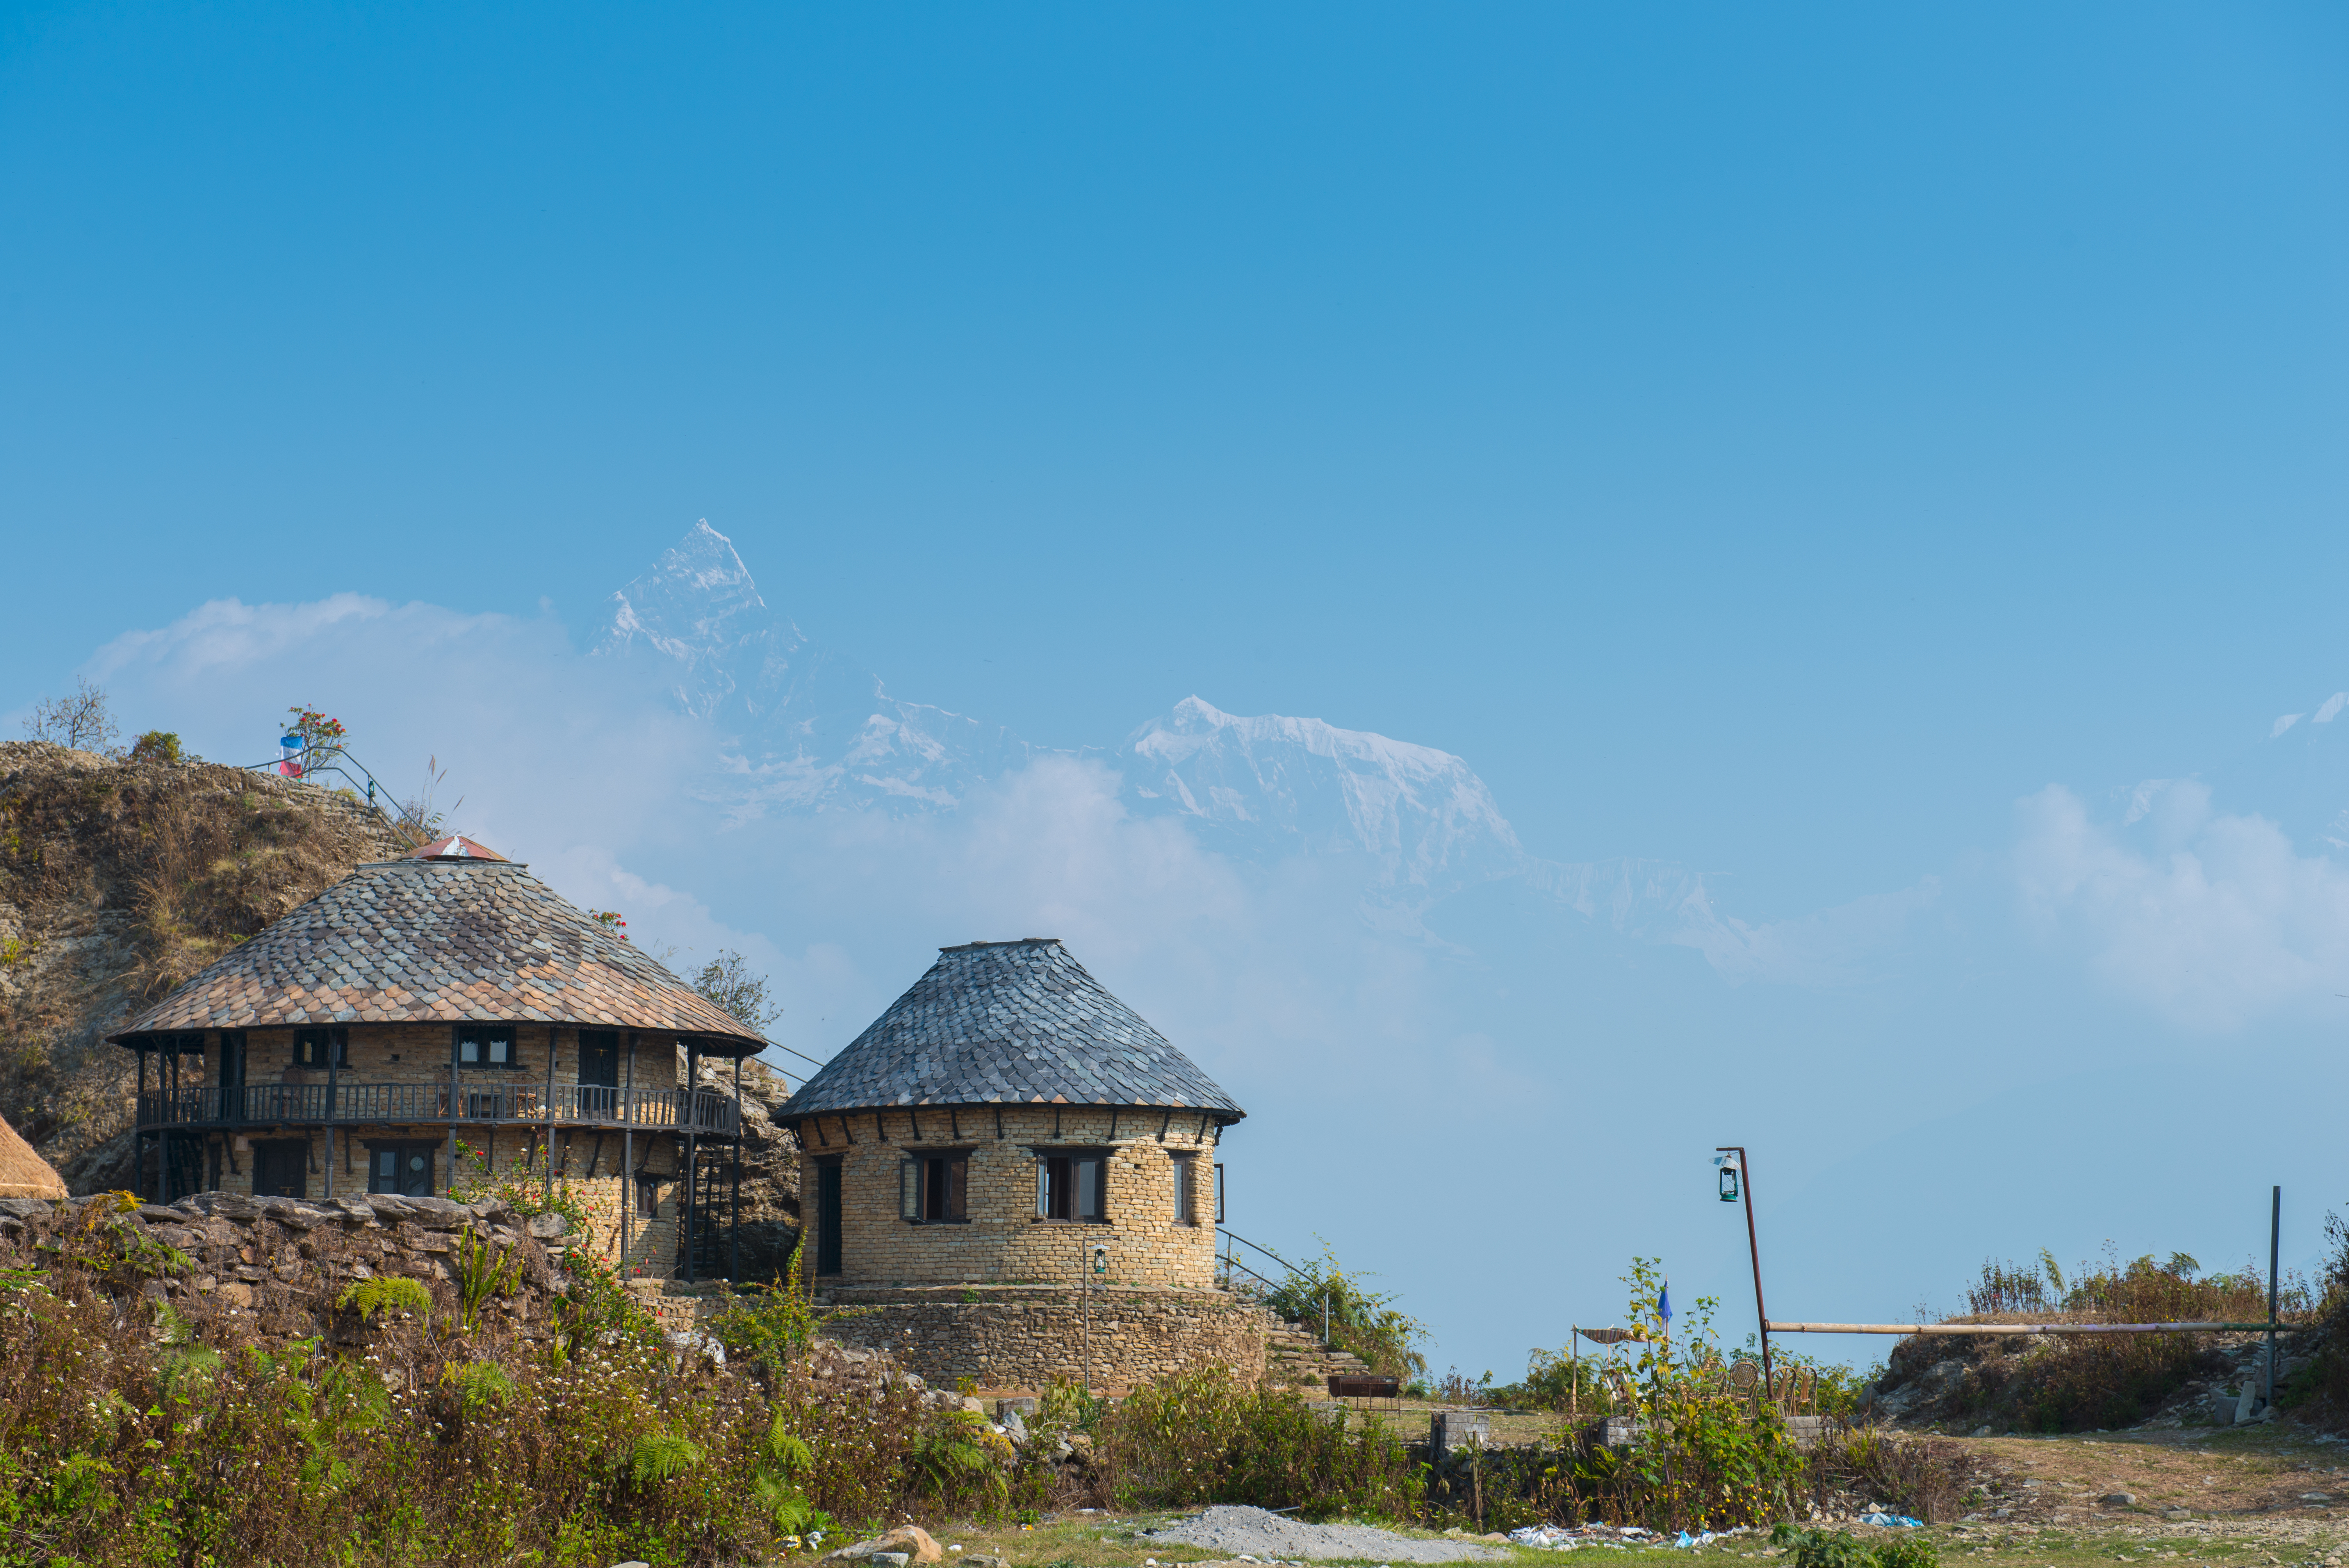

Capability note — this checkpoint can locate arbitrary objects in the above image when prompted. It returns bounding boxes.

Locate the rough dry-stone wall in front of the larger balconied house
[0,1192,564,1340]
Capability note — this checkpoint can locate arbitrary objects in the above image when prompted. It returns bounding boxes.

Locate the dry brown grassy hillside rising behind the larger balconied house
[0,742,406,1192]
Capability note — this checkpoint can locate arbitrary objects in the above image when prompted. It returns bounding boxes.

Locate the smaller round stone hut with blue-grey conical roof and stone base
[775,937,1264,1392]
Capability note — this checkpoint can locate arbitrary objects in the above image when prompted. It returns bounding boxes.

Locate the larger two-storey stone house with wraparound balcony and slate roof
[110,838,763,1279]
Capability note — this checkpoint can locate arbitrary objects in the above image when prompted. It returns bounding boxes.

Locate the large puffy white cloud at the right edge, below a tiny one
[2016,779,2349,1033]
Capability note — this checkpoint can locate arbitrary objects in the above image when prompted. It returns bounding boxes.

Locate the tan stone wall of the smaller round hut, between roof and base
[798,1106,1217,1286]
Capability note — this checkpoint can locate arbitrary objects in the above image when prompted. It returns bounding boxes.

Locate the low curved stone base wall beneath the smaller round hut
[820,1286,1271,1394]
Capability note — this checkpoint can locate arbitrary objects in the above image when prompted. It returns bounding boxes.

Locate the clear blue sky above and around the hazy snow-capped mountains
[0,5,2349,1371]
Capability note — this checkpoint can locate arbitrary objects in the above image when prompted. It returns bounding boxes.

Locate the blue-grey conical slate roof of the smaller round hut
[775,937,1247,1122]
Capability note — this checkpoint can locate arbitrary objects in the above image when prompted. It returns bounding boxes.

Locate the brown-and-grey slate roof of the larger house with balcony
[108,859,761,1056]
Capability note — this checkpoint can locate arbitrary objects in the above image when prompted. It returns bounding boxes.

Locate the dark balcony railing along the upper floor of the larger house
[139,1085,742,1139]
